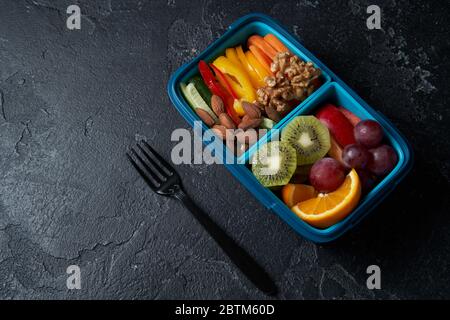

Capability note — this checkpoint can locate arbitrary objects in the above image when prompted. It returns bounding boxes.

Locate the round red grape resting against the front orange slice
[309,158,345,192]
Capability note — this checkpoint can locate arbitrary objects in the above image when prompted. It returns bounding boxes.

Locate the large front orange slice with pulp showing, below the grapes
[292,169,361,228]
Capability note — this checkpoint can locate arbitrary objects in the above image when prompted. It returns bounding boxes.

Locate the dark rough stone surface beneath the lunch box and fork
[0,0,450,299]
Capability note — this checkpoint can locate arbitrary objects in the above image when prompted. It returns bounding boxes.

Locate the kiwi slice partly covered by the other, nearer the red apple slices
[281,116,331,165]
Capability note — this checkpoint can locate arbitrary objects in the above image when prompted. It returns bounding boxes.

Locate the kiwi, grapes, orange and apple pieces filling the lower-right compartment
[251,104,398,228]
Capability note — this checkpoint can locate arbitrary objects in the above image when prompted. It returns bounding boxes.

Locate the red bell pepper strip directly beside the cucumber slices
[198,60,241,125]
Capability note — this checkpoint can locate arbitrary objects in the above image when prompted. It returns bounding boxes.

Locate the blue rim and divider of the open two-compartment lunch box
[167,13,413,242]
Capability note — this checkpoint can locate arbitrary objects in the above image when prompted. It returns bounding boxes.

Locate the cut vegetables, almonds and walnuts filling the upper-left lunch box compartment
[180,34,321,151]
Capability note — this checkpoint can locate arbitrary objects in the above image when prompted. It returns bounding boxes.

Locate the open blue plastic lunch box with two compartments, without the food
[168,14,413,243]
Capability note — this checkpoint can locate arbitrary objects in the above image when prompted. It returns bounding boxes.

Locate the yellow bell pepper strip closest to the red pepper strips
[213,56,256,102]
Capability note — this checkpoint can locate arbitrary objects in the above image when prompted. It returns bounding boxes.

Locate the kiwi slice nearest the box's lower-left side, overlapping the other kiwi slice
[252,141,297,188]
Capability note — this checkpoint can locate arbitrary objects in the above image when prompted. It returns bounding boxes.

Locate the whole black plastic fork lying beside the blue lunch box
[127,140,277,295]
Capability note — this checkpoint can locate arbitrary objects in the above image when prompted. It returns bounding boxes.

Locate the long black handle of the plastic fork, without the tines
[174,188,277,295]
